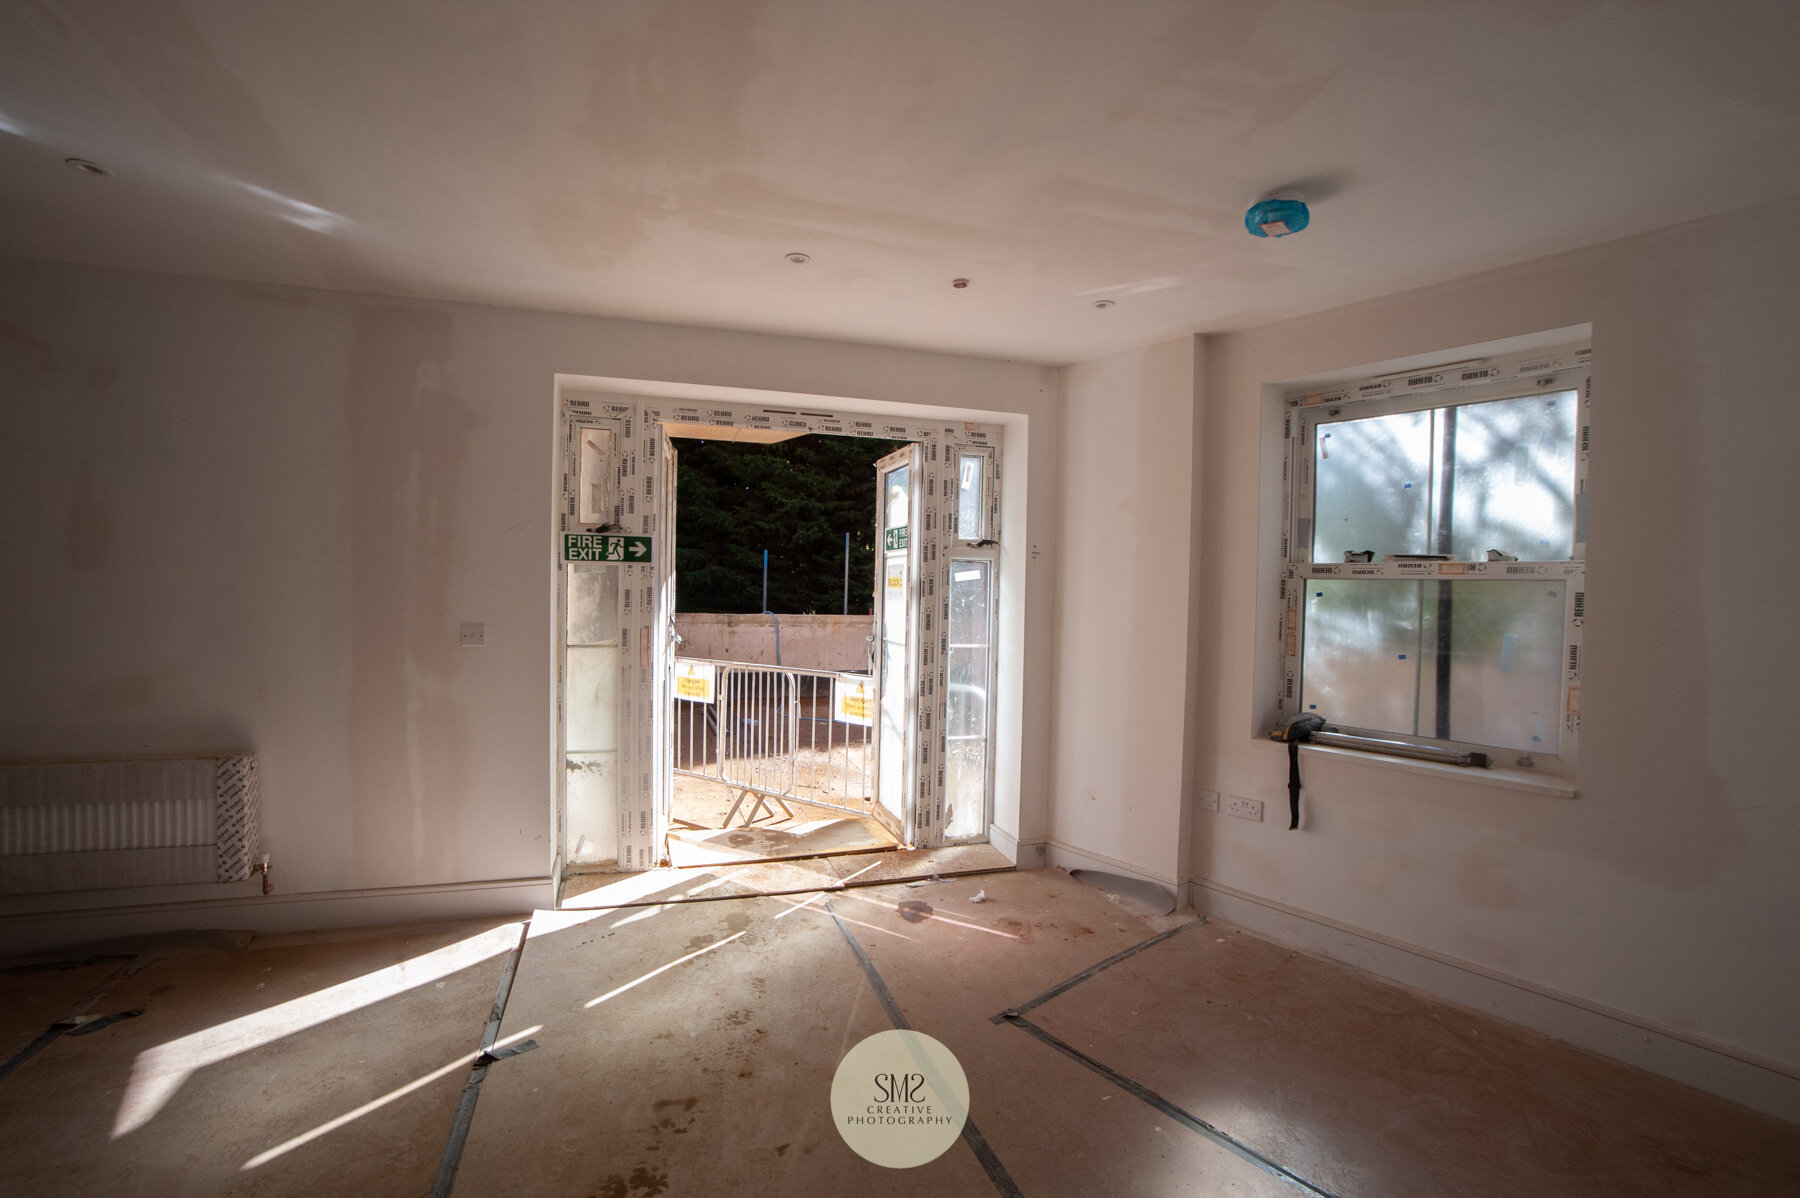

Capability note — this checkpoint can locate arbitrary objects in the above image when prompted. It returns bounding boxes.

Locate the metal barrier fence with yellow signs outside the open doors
[675,658,875,826]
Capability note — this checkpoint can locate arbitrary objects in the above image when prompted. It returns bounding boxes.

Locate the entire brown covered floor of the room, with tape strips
[0,867,1800,1198]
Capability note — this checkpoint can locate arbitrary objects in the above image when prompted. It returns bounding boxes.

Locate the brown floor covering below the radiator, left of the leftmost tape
[0,921,520,1198]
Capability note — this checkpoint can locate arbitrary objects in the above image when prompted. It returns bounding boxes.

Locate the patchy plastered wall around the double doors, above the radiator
[0,261,1057,913]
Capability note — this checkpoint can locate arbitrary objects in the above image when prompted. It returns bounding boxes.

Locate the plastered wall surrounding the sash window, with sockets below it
[1188,201,1800,1068]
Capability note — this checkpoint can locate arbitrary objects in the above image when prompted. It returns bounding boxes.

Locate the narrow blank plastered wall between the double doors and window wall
[1049,336,1199,883]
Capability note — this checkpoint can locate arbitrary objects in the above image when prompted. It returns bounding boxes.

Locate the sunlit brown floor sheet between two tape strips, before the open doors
[446,898,990,1198]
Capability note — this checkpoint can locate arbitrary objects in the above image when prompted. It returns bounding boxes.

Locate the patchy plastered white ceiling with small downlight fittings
[0,0,1800,363]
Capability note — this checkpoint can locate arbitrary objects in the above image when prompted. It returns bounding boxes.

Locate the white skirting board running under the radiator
[0,878,556,955]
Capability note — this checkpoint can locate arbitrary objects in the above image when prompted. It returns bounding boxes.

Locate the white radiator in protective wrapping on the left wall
[0,754,261,894]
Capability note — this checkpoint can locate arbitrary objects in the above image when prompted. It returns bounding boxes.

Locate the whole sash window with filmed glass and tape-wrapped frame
[1280,349,1589,768]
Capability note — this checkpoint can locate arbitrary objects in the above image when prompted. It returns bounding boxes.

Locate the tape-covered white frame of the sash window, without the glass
[1276,345,1593,777]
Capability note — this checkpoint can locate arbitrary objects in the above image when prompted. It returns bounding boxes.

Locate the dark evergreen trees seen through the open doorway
[675,435,905,615]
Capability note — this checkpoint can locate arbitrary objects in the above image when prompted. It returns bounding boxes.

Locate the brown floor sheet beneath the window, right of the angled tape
[1028,923,1800,1198]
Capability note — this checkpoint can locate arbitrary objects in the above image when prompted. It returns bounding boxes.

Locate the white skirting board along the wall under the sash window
[1186,880,1800,1122]
